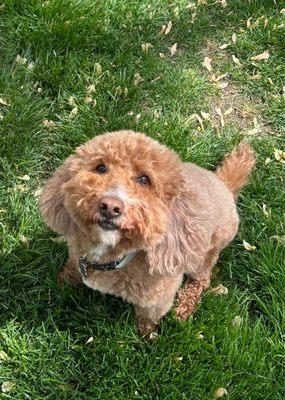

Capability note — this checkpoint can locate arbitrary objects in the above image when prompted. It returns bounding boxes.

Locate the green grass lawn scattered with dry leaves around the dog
[0,0,285,400]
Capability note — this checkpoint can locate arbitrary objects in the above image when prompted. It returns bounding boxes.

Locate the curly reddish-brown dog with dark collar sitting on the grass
[40,131,254,334]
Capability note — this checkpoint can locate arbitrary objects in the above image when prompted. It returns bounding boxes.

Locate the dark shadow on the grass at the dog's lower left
[0,232,135,336]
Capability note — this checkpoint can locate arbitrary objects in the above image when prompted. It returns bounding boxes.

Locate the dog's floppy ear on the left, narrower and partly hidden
[39,156,74,235]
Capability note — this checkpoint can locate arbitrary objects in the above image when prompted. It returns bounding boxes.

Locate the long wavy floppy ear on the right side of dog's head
[147,193,208,275]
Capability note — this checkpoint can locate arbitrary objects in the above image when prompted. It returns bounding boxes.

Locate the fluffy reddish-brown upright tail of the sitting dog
[216,142,255,199]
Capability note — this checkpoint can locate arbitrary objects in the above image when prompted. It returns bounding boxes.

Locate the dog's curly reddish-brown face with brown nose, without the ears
[40,131,183,245]
